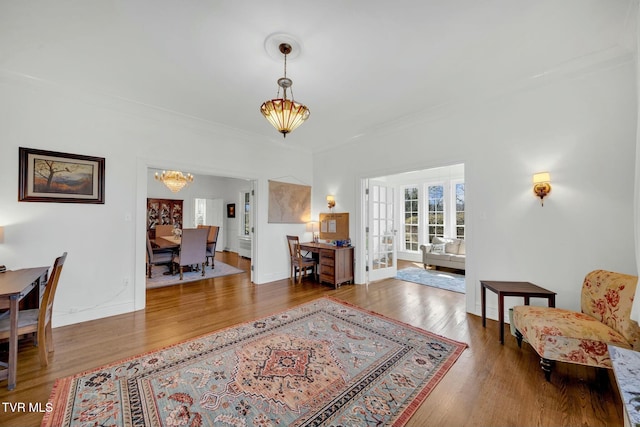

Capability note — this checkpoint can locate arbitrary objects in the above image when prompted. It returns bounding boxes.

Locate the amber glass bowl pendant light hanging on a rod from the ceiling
[260,43,309,138]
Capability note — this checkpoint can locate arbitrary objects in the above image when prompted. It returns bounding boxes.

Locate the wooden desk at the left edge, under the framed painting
[0,267,49,390]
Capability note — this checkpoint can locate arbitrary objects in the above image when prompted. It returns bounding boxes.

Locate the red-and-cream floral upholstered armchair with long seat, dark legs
[512,270,640,381]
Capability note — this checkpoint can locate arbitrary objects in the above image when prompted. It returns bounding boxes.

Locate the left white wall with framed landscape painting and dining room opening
[0,72,312,326]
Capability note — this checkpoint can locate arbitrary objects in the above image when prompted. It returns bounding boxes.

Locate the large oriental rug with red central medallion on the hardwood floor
[42,298,467,427]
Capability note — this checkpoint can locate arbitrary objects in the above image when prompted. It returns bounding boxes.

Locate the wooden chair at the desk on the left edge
[0,252,67,366]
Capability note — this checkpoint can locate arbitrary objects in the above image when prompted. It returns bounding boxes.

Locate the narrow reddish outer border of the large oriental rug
[41,296,469,427]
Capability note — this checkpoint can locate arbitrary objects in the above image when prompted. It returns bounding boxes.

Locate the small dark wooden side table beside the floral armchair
[480,280,556,344]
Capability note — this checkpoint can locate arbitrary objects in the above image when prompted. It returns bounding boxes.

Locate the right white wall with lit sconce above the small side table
[314,58,637,318]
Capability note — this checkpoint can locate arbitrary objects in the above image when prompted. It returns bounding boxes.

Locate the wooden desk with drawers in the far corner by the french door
[300,242,354,288]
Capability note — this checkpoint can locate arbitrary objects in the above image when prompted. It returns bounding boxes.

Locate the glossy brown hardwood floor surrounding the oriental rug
[0,253,623,426]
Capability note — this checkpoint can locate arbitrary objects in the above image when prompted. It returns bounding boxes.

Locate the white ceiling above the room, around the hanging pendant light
[0,0,638,150]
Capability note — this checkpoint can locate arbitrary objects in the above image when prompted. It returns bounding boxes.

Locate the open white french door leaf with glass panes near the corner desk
[367,180,398,281]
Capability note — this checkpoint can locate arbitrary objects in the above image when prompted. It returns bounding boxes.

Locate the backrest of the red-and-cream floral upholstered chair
[580,270,640,351]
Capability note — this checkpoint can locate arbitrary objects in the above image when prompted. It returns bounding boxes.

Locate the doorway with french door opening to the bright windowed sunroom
[361,164,465,283]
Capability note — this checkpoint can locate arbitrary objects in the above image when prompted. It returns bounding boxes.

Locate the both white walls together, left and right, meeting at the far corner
[0,53,637,326]
